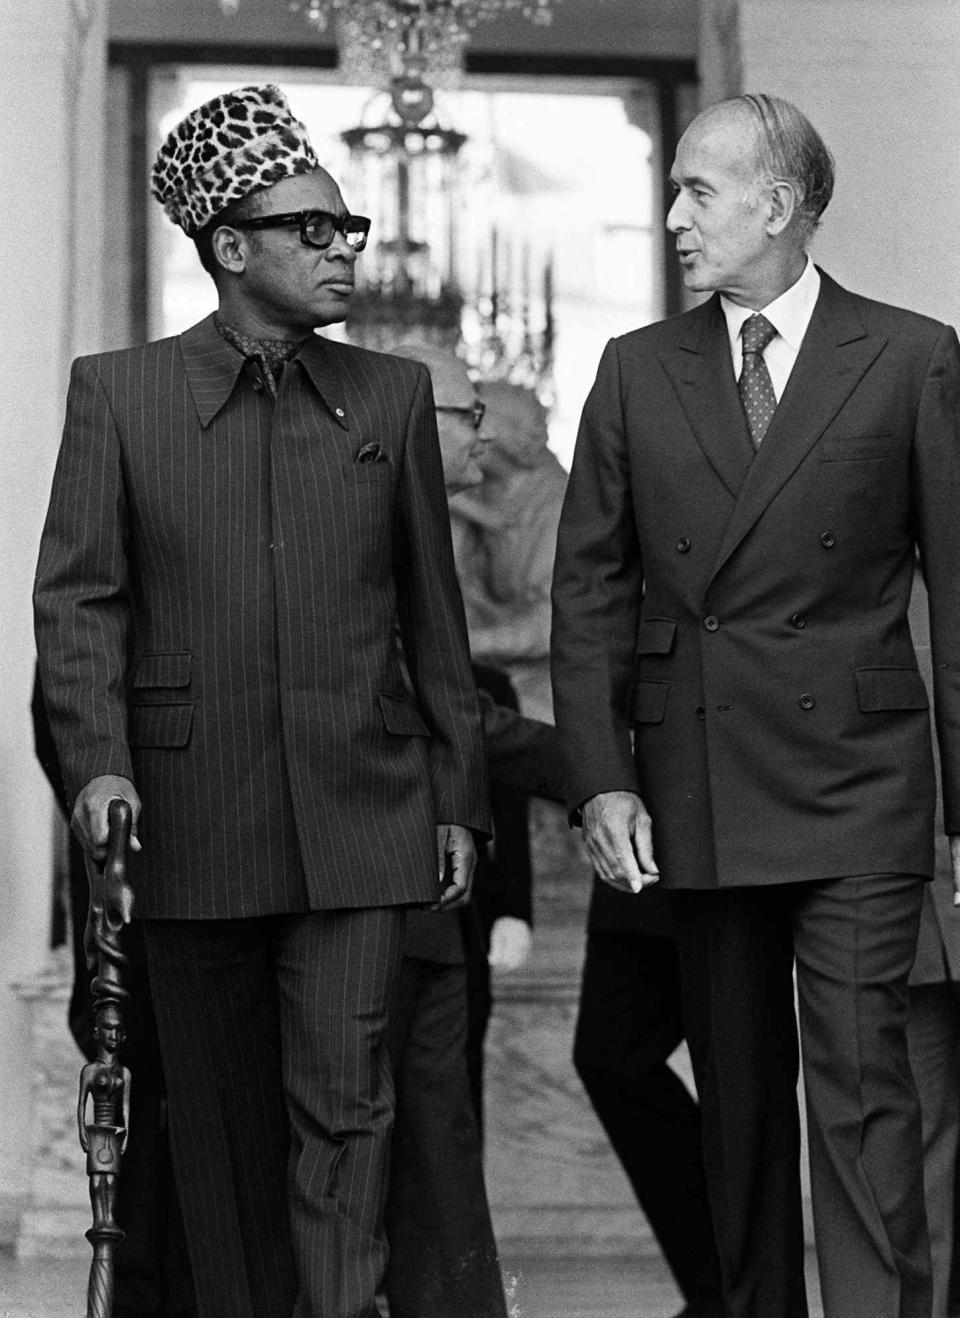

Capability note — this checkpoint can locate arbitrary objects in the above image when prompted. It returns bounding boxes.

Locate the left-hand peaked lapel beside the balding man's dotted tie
[661,297,754,498]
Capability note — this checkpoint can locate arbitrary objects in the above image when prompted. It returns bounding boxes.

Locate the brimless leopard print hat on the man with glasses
[150,83,318,236]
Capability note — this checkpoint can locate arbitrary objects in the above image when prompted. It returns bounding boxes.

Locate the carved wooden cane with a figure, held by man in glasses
[76,797,133,1318]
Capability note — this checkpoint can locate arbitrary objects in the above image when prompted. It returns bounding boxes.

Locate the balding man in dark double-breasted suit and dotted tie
[554,96,960,1318]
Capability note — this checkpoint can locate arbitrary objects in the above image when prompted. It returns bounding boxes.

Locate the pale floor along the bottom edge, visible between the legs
[0,1253,823,1318]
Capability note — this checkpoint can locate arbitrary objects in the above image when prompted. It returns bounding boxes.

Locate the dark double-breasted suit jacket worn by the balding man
[553,274,960,887]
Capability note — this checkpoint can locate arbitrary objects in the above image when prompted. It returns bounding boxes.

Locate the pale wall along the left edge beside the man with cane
[0,0,105,1212]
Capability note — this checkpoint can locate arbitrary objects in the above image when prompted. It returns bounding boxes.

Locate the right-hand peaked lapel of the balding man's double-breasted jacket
[712,273,886,576]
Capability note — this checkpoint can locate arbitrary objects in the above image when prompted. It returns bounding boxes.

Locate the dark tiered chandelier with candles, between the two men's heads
[340,88,555,403]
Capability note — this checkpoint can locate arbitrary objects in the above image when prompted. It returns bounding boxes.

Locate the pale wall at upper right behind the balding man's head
[704,0,960,324]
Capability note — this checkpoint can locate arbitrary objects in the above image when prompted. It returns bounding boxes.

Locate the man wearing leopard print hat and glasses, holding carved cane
[36,86,487,1318]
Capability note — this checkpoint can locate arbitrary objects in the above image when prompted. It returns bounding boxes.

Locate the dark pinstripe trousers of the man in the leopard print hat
[135,907,404,1318]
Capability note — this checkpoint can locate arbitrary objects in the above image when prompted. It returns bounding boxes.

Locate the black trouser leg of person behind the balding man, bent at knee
[574,929,720,1305]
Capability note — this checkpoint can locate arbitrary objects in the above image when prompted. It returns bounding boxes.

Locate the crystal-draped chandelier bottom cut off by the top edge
[220,0,553,87]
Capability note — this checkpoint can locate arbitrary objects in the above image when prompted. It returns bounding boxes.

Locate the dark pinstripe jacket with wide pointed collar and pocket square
[34,316,487,919]
